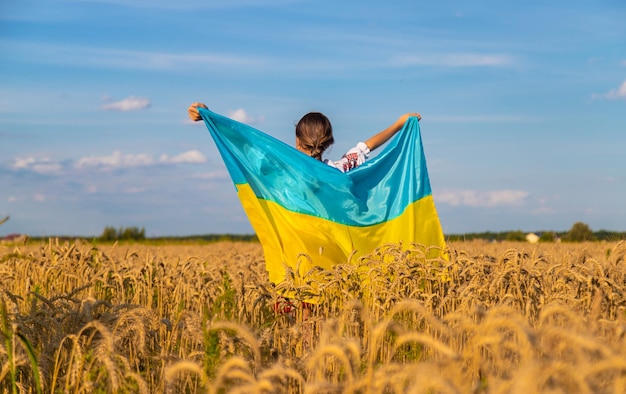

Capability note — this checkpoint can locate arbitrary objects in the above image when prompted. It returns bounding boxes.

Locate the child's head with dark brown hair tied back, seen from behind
[296,112,335,160]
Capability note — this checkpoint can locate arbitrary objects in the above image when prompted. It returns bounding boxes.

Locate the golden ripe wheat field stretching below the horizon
[0,240,626,394]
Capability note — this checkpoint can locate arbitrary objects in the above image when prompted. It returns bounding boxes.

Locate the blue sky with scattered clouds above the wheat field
[0,0,626,236]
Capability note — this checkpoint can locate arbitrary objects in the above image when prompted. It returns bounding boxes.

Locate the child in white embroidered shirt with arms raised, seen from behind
[187,103,422,172]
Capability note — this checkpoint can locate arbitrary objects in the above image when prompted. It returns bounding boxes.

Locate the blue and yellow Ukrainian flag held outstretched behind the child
[198,108,445,283]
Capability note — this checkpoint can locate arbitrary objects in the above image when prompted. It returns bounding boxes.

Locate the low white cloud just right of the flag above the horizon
[433,190,529,207]
